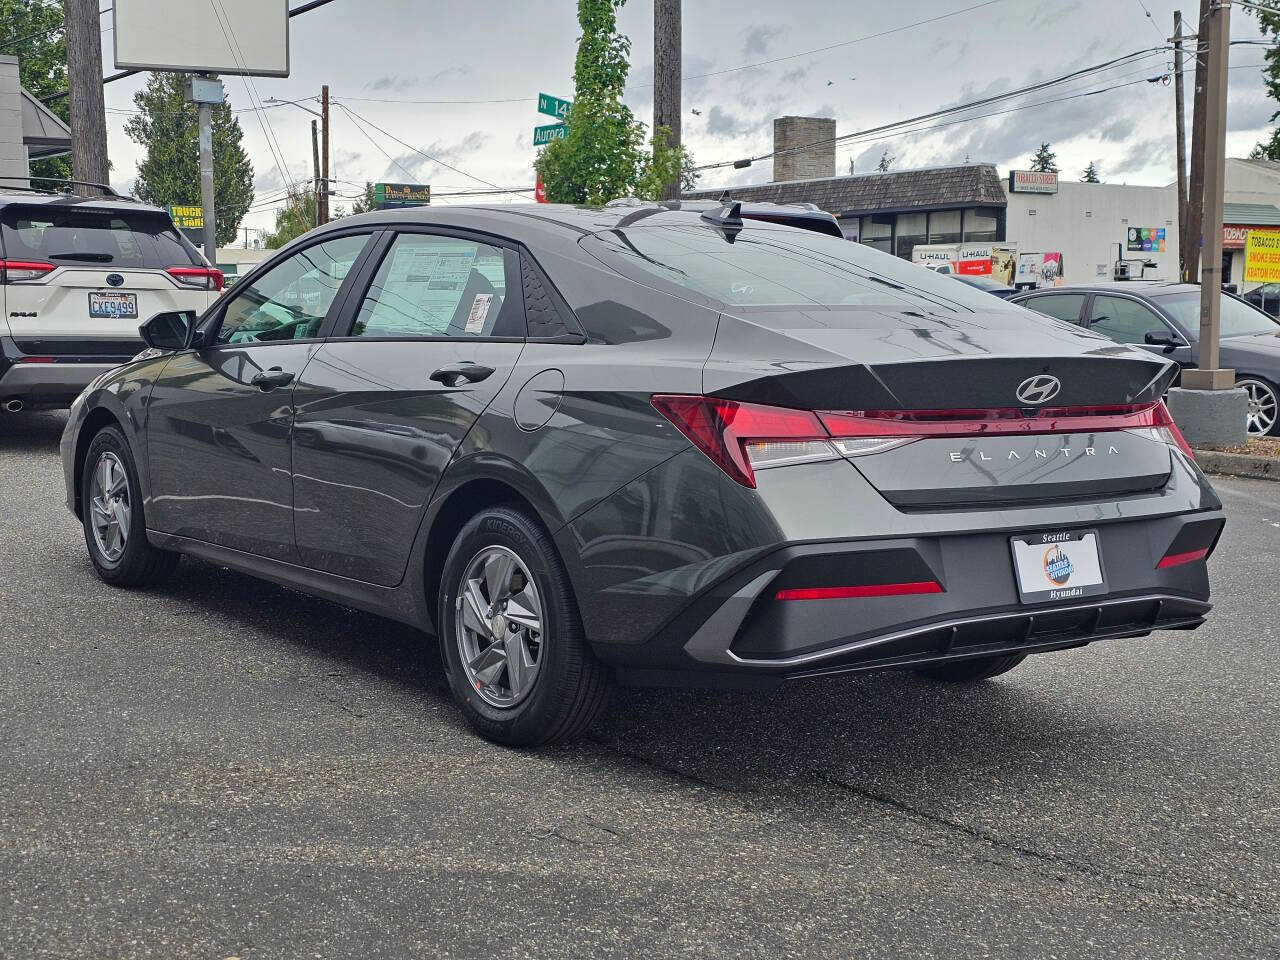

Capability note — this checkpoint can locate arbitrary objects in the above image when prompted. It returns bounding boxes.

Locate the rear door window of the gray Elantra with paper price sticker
[351,233,521,338]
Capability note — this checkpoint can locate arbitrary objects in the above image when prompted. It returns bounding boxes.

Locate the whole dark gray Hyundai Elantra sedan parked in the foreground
[61,202,1224,745]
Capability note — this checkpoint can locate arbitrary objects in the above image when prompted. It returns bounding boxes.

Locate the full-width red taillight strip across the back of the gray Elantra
[652,396,1194,488]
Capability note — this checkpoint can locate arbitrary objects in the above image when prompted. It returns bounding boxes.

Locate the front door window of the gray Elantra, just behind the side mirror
[214,233,369,343]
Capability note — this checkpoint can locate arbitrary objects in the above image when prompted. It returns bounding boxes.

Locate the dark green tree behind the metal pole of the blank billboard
[124,73,253,246]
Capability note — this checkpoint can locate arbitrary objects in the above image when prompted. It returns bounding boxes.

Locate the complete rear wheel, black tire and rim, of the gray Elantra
[436,507,608,746]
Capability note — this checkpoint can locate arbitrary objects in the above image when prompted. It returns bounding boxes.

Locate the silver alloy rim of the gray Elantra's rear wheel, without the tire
[454,547,543,709]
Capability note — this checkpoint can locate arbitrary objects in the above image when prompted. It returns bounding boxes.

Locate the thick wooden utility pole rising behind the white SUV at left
[63,0,110,196]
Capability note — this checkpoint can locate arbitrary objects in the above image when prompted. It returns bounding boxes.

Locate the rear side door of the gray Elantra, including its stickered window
[293,228,526,585]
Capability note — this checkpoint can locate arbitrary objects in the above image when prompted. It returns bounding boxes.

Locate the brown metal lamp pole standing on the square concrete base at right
[1183,0,1235,390]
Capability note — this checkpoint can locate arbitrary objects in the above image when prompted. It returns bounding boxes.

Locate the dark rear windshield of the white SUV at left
[0,206,200,270]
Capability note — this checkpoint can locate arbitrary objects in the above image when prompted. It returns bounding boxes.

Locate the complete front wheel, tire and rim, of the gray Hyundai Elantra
[81,426,179,588]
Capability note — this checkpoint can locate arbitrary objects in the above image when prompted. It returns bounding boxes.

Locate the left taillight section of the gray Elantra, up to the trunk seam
[652,396,838,486]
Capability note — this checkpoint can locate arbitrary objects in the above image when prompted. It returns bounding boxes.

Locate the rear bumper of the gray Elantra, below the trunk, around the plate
[596,511,1225,682]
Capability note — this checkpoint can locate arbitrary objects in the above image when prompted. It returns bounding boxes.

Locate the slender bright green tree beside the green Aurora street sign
[534,0,691,204]
